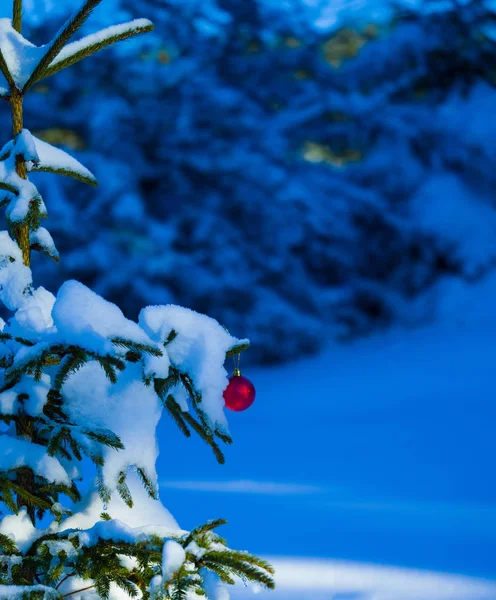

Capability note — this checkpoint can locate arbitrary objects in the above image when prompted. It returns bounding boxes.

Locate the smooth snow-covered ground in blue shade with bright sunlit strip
[159,282,496,600]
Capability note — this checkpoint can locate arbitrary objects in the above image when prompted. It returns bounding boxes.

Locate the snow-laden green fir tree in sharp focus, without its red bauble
[0,0,274,600]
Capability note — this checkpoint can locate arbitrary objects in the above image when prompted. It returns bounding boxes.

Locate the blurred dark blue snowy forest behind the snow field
[0,0,496,364]
